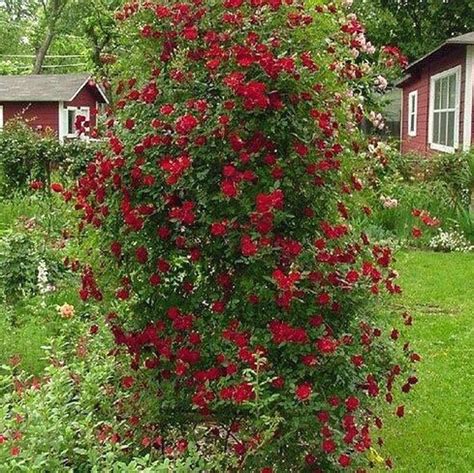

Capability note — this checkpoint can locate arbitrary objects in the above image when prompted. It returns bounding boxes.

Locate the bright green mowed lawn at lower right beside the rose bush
[384,252,474,473]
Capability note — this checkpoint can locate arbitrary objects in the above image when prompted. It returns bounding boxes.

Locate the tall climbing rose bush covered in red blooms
[70,0,418,472]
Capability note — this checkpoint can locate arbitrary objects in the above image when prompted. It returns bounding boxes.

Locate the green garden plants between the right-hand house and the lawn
[360,143,474,246]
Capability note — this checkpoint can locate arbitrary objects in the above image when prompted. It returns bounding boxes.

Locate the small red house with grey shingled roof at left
[0,73,108,142]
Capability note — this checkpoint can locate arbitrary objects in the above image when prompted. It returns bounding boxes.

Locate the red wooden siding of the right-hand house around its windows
[401,44,468,154]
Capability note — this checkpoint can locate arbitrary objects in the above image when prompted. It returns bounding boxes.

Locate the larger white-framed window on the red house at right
[429,66,461,152]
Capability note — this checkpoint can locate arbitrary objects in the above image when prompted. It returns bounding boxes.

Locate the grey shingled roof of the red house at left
[0,72,107,102]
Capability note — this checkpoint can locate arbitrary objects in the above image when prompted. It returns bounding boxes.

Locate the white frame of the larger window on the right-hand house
[428,66,462,153]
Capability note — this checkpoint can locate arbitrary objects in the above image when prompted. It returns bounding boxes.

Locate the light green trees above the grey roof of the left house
[0,0,122,74]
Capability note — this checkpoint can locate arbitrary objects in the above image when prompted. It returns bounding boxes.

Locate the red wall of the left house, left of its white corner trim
[0,102,59,134]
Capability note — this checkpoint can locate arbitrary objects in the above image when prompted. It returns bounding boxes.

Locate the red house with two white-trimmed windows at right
[398,32,474,155]
